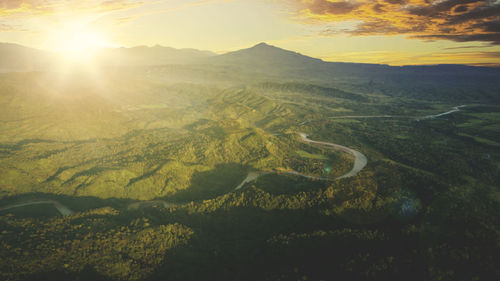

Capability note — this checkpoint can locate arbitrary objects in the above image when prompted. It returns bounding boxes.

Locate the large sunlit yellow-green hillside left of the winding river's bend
[0,72,358,201]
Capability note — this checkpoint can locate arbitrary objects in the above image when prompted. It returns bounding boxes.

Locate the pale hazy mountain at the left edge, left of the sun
[0,43,54,72]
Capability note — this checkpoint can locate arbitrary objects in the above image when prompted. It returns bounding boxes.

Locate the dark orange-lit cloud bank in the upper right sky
[288,0,500,44]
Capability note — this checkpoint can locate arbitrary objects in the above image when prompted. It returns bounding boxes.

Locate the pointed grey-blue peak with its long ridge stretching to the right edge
[207,43,500,83]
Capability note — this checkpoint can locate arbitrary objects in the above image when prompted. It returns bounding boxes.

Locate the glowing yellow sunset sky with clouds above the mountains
[0,0,500,66]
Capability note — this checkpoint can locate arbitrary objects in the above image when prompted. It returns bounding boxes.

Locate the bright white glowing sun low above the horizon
[47,27,114,61]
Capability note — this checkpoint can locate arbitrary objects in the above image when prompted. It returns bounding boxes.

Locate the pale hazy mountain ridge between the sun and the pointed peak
[97,45,215,66]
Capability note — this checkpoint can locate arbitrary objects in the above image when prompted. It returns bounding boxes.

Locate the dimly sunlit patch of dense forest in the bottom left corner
[0,208,193,280]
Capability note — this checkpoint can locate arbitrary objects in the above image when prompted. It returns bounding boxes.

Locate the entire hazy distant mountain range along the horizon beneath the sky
[0,40,500,78]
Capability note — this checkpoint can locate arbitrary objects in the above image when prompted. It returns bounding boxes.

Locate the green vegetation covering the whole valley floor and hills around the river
[0,60,500,281]
